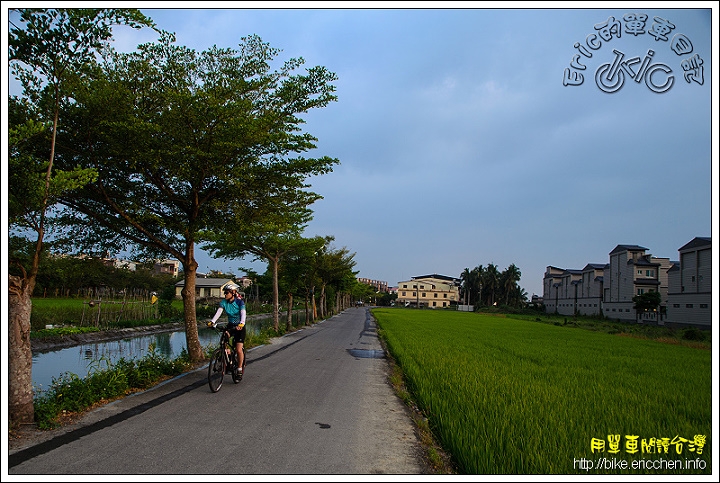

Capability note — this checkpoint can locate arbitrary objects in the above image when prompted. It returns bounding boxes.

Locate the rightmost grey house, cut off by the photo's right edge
[666,237,712,328]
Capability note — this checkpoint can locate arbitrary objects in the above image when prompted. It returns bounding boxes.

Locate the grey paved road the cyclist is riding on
[8,308,426,475]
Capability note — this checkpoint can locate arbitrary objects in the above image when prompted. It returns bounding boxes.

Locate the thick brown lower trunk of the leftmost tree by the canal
[8,275,35,427]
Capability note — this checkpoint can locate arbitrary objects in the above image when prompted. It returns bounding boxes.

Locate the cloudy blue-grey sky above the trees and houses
[2,2,718,298]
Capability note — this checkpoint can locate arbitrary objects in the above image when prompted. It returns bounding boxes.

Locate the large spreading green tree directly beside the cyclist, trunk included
[53,32,337,361]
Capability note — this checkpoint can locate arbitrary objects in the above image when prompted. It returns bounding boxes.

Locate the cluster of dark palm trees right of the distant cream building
[460,263,527,308]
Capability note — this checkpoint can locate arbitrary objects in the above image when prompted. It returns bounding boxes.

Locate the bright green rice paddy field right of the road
[372,308,712,475]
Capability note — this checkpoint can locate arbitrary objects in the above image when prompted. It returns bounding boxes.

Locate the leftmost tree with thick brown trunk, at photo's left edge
[8,9,153,424]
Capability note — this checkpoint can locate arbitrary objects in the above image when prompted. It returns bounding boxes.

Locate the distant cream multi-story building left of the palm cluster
[397,274,460,308]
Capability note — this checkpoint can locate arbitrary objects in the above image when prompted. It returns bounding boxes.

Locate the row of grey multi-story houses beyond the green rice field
[543,237,712,327]
